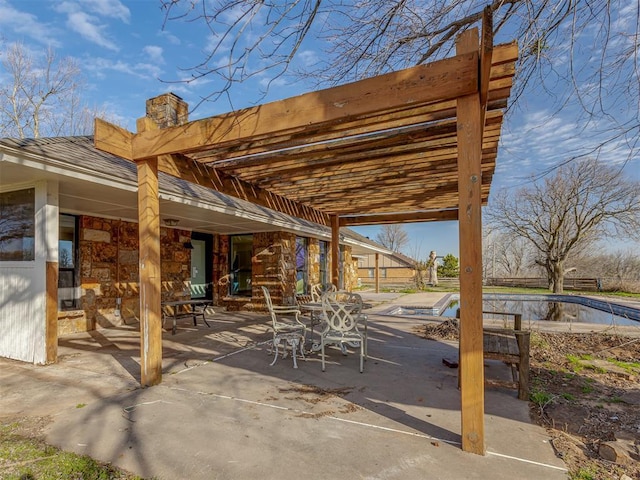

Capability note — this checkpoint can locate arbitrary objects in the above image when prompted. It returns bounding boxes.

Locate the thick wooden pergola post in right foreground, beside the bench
[456,29,485,455]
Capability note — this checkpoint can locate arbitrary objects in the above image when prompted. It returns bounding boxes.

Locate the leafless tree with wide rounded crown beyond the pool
[487,159,640,293]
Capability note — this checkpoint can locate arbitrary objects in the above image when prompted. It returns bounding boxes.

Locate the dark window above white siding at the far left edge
[0,188,35,262]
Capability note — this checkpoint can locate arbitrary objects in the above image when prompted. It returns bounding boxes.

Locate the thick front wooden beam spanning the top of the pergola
[132,50,478,159]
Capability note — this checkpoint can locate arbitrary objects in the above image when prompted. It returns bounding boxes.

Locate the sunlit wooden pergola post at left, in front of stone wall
[136,158,162,386]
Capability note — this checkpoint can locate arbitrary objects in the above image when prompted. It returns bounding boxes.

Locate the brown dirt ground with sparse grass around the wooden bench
[416,321,640,480]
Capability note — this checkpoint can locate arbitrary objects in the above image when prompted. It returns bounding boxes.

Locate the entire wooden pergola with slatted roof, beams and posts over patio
[95,15,518,454]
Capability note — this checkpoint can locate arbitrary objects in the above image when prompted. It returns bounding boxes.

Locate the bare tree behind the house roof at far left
[0,43,99,138]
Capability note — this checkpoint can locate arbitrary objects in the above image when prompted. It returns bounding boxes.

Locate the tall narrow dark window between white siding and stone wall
[58,215,80,310]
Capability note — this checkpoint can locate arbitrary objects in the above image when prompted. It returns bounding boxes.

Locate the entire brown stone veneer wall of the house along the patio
[58,216,358,335]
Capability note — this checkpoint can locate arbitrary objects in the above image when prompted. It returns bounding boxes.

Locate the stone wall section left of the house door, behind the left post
[58,215,191,335]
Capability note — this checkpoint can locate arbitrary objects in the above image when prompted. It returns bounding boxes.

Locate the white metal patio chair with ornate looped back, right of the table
[320,292,367,373]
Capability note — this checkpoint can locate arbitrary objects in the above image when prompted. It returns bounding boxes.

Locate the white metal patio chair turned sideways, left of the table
[262,287,307,368]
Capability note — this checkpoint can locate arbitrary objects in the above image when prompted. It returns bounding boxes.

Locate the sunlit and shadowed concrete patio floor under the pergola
[0,294,567,480]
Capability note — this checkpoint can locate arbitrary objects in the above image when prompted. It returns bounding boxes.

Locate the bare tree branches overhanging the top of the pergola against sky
[161,0,640,161]
